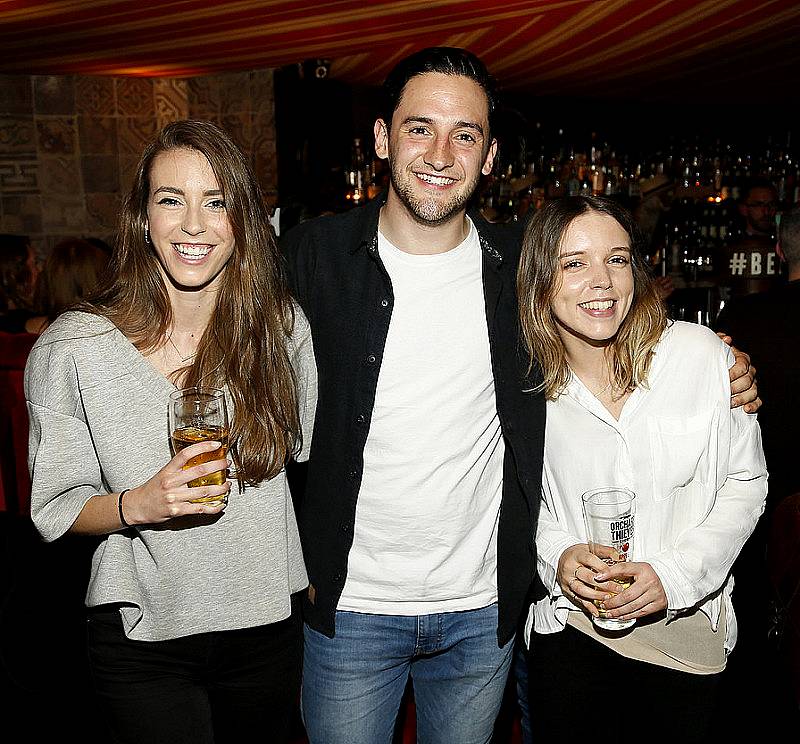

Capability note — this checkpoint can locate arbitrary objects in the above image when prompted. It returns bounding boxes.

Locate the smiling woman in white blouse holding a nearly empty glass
[518,197,766,742]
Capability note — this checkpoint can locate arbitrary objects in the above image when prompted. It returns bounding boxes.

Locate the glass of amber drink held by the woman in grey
[168,387,229,504]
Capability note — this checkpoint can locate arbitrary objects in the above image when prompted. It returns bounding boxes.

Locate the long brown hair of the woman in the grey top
[83,121,300,484]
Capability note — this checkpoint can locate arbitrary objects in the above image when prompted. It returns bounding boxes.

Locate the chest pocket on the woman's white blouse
[647,413,712,501]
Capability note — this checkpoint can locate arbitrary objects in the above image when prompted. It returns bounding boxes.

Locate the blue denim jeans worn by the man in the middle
[302,604,514,744]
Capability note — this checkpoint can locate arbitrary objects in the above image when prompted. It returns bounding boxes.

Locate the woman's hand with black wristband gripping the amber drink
[123,442,231,525]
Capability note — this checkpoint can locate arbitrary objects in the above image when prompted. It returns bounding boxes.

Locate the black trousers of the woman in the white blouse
[528,626,720,744]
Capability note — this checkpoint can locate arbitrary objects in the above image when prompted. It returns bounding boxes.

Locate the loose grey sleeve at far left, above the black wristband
[25,336,107,542]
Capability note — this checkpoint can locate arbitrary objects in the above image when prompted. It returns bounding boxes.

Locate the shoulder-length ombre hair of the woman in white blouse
[517,196,667,400]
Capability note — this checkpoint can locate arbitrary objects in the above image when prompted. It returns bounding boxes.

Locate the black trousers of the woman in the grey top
[88,598,302,744]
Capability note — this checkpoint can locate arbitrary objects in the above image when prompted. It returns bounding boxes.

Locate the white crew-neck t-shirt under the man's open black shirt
[338,218,504,615]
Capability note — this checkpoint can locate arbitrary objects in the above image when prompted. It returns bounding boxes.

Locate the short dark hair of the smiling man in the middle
[382,47,498,130]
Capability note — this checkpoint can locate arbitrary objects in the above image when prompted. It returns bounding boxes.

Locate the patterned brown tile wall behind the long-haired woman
[0,70,277,253]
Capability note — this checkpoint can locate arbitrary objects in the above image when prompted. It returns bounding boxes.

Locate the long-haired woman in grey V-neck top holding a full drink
[26,121,316,744]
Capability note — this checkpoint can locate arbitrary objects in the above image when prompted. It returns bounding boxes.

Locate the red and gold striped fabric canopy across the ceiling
[0,0,800,102]
